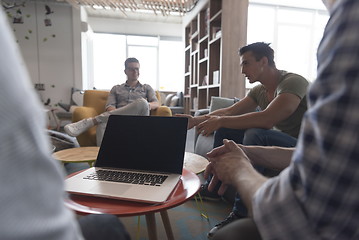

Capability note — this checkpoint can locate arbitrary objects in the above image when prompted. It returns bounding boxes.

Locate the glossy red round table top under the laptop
[65,169,201,217]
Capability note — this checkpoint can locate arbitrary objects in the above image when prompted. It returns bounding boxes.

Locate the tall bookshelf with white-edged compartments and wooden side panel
[184,0,248,115]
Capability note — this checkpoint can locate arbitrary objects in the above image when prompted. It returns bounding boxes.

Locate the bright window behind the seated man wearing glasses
[93,33,184,91]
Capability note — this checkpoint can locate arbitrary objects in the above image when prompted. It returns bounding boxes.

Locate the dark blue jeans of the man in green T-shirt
[212,128,297,216]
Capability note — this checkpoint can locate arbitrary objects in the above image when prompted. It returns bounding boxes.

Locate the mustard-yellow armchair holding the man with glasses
[72,90,172,147]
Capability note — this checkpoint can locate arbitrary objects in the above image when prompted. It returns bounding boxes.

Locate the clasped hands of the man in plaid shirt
[204,139,251,195]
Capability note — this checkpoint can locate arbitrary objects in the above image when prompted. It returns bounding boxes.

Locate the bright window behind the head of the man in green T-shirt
[246,3,329,88]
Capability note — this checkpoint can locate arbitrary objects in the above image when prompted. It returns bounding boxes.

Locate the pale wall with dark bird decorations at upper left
[8,1,82,106]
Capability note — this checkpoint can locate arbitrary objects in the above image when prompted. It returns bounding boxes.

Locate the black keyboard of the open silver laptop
[84,170,168,186]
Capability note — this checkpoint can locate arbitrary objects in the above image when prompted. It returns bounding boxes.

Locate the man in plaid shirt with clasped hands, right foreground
[206,0,359,240]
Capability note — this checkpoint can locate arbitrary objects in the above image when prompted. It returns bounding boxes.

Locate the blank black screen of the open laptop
[95,115,187,174]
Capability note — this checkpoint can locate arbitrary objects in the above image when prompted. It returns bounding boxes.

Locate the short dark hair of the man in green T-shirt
[239,42,275,67]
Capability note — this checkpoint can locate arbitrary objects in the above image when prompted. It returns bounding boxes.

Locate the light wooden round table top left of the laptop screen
[52,147,100,167]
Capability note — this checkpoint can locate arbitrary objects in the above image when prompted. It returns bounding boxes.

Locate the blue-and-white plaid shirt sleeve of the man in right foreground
[253,0,359,240]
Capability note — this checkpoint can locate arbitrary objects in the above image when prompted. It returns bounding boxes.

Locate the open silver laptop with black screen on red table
[65,115,188,203]
